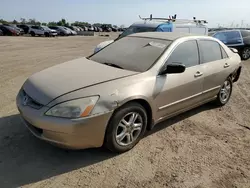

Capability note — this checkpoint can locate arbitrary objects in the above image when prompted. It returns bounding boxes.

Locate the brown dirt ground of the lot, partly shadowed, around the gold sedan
[0,37,250,188]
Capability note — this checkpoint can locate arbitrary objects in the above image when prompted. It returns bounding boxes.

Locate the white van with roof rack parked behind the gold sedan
[94,15,208,52]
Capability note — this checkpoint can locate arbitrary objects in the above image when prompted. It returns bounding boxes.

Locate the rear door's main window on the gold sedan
[198,40,221,63]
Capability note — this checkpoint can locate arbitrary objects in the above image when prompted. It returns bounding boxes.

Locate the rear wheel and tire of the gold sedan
[215,77,233,106]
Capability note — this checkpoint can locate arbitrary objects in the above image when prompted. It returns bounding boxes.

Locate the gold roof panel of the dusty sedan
[128,32,205,41]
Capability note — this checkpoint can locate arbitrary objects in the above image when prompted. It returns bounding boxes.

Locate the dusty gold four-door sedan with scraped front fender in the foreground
[16,32,241,153]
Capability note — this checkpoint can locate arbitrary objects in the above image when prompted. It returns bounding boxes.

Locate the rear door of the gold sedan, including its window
[198,39,231,100]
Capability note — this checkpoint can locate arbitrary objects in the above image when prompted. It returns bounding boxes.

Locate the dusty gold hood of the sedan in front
[23,58,137,105]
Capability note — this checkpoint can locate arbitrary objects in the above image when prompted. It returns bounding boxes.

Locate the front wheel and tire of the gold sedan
[104,102,147,153]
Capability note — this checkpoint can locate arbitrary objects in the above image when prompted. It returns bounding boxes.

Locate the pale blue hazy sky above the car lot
[0,0,250,27]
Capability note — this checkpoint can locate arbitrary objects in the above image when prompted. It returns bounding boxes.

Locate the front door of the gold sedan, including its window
[155,40,204,120]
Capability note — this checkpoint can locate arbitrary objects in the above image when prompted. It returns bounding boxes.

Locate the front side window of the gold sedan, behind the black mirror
[167,40,199,67]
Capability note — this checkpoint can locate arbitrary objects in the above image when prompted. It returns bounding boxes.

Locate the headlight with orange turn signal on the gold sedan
[45,96,99,118]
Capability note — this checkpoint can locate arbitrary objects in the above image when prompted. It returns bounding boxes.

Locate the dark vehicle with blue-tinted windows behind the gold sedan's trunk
[212,30,250,60]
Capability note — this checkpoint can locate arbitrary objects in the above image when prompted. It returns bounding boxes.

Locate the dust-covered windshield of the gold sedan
[89,37,172,72]
